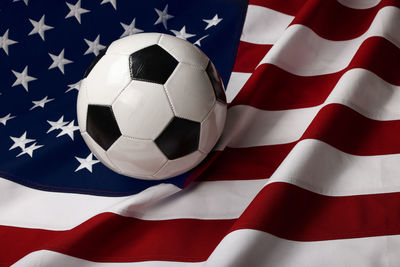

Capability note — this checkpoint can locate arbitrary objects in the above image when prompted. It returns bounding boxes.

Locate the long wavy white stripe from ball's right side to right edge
[218,69,400,149]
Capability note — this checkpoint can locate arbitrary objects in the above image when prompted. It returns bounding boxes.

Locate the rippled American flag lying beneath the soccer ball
[0,0,400,267]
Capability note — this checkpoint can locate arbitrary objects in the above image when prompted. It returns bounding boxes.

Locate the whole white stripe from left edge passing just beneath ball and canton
[0,179,265,230]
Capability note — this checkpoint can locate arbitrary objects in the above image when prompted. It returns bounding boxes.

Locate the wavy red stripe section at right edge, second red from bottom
[300,104,400,156]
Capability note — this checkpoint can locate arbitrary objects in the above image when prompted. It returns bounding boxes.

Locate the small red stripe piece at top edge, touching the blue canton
[249,0,307,16]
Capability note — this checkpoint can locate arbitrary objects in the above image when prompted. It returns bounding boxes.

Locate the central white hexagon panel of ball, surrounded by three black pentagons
[112,81,174,140]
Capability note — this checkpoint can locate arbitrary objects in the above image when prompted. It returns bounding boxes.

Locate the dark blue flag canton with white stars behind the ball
[0,0,247,196]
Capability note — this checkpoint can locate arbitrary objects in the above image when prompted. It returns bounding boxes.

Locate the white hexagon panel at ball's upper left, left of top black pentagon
[85,54,131,105]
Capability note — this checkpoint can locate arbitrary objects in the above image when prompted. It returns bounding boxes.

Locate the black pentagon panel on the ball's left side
[86,105,121,150]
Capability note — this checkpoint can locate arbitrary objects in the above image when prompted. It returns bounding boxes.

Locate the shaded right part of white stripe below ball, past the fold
[128,179,266,220]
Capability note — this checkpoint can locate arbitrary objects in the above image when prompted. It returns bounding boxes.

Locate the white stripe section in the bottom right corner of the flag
[206,228,400,267]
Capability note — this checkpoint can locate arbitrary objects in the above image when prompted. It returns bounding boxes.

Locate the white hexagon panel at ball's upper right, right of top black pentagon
[164,63,216,122]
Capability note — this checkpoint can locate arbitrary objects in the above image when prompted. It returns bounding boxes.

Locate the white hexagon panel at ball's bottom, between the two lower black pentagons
[106,136,167,179]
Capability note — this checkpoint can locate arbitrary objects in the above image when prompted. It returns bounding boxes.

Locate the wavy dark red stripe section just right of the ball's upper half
[230,64,343,110]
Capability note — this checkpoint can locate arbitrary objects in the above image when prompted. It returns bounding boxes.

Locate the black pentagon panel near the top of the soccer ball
[129,45,178,84]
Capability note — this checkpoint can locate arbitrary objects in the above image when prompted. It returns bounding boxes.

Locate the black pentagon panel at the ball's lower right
[155,117,200,159]
